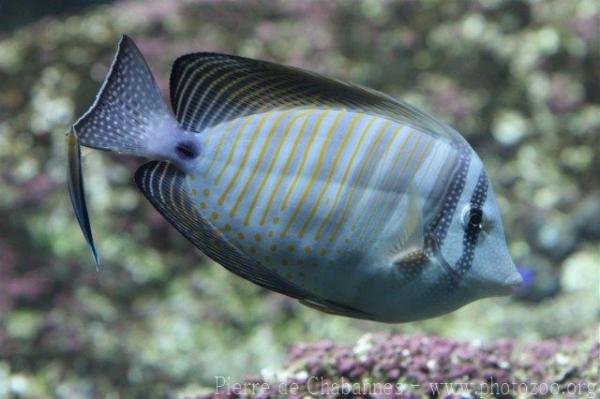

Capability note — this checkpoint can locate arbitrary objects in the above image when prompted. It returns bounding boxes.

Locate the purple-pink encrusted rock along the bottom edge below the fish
[197,329,600,399]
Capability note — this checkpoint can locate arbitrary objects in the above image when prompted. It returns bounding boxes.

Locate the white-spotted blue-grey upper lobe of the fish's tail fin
[73,36,178,157]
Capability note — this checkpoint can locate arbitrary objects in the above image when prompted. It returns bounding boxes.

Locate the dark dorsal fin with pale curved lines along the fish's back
[170,53,464,142]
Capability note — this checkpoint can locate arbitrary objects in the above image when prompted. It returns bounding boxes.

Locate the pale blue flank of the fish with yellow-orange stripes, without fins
[185,109,452,310]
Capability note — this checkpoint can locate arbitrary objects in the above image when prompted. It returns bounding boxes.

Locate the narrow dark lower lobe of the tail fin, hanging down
[67,129,100,270]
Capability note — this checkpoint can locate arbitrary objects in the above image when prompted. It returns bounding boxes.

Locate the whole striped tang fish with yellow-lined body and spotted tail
[68,36,522,323]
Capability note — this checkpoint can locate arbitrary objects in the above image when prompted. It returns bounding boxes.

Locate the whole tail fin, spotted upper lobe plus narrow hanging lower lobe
[68,36,190,266]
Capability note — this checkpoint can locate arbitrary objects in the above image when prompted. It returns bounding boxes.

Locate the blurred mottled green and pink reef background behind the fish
[0,0,600,397]
